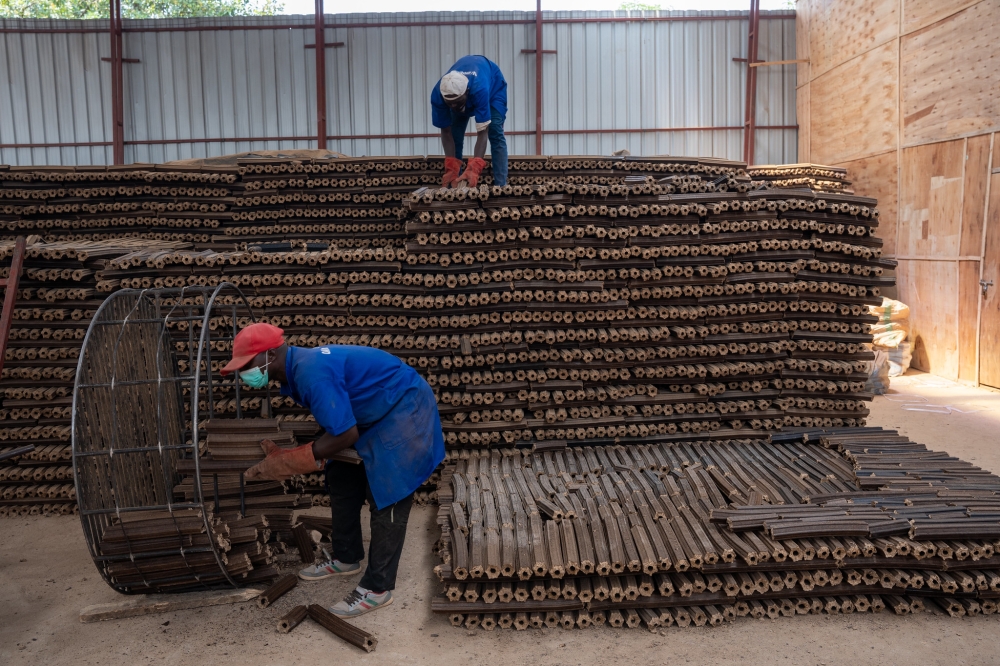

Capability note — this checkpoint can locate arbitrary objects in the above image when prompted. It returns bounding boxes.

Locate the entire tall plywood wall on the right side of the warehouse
[796,0,1000,387]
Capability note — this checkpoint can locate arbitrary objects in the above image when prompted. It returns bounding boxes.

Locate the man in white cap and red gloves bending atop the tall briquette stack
[431,56,507,187]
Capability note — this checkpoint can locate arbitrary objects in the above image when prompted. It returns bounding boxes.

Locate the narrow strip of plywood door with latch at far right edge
[979,174,1000,388]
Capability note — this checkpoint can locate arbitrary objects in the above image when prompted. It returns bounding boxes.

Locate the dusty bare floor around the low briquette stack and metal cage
[0,374,1000,666]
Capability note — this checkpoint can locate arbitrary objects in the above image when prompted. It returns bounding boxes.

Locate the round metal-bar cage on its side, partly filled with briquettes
[72,283,253,593]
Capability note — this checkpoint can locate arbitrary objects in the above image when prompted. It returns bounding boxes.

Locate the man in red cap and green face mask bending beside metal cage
[222,323,444,617]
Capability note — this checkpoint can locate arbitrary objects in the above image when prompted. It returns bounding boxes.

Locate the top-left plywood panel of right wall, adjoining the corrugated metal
[809,0,899,78]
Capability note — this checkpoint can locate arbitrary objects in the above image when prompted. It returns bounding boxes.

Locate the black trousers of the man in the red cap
[326,461,413,592]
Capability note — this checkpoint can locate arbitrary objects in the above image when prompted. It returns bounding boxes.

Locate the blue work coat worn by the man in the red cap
[281,345,444,509]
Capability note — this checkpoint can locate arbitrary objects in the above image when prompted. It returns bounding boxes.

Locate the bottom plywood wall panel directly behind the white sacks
[896,260,959,379]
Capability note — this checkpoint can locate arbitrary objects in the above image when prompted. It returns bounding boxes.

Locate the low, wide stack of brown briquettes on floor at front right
[432,429,1000,630]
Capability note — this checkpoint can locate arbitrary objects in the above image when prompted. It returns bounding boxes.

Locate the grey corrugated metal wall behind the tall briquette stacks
[0,12,797,164]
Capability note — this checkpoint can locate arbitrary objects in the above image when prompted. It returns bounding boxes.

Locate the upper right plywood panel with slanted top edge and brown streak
[900,0,1000,145]
